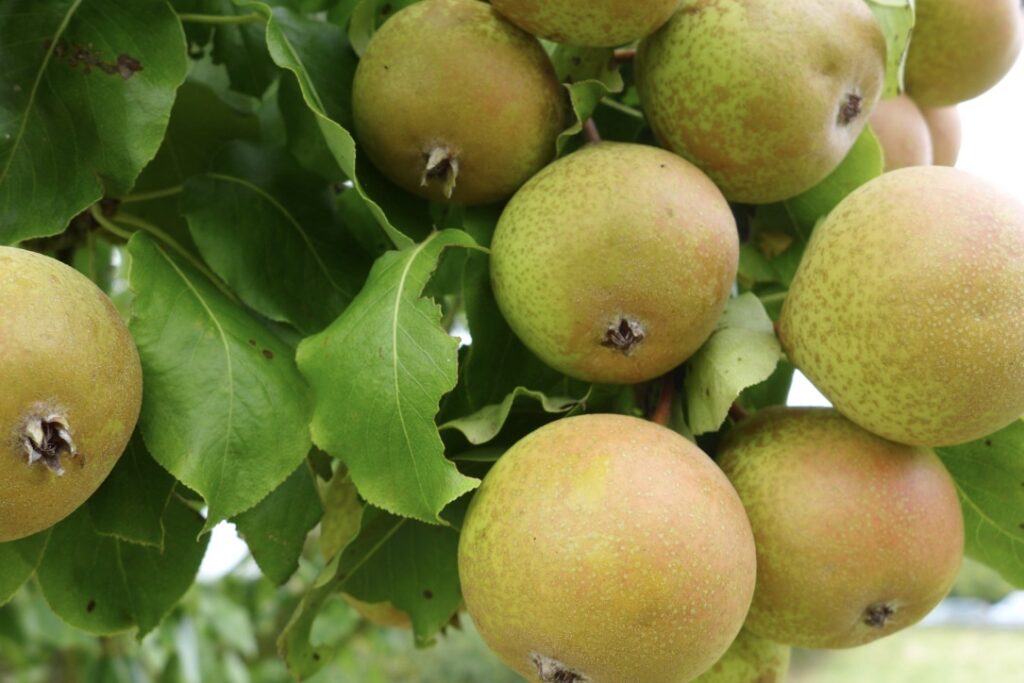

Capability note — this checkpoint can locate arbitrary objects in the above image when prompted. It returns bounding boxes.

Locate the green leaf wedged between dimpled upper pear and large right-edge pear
[785,126,885,229]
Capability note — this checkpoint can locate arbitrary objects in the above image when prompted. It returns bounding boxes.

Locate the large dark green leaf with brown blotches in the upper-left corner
[0,0,186,244]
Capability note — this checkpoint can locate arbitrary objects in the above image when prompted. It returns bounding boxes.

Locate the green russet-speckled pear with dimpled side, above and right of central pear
[635,0,886,204]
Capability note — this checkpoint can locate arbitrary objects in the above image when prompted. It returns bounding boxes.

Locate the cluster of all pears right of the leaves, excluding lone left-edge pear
[352,0,1024,683]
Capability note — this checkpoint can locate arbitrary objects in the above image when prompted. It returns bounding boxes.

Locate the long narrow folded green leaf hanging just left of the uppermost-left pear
[236,0,426,248]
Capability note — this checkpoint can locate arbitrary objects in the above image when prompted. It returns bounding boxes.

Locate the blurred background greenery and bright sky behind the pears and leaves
[0,24,1024,683]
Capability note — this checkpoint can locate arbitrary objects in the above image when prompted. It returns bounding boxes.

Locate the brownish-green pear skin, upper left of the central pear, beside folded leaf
[352,0,568,205]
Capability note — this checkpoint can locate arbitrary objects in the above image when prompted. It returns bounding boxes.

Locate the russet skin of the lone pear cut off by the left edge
[0,247,142,543]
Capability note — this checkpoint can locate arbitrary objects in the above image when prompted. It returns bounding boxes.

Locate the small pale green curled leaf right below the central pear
[686,294,782,434]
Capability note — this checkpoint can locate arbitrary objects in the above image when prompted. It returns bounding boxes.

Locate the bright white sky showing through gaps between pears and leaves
[199,53,1024,582]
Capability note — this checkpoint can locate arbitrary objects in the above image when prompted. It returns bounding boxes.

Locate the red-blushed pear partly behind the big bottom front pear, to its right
[719,408,964,648]
